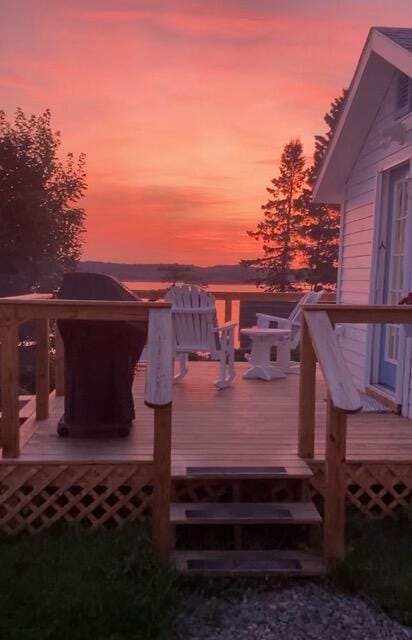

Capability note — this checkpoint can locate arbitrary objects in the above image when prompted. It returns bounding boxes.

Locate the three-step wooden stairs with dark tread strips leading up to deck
[170,459,327,576]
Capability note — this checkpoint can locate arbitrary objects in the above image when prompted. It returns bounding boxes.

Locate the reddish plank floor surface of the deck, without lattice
[15,362,412,478]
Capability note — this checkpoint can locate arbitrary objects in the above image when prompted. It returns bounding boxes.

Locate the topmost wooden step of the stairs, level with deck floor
[186,458,313,479]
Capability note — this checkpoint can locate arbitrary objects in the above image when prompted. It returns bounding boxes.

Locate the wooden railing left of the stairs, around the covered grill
[0,294,173,559]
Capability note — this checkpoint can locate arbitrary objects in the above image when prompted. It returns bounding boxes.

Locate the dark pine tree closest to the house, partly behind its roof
[301,91,346,287]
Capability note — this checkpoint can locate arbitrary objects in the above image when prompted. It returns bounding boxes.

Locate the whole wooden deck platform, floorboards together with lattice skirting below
[0,362,412,535]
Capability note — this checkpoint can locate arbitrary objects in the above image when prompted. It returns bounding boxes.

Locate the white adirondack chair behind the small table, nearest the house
[246,291,323,374]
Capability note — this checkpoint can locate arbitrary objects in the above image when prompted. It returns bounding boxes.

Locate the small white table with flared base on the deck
[240,327,291,381]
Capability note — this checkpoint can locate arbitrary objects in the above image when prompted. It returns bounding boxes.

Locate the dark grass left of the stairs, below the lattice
[0,526,179,640]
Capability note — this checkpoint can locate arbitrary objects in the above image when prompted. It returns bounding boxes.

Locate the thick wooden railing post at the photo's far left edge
[0,305,20,458]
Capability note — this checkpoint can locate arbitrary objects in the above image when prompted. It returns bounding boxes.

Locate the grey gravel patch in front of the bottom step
[178,582,412,640]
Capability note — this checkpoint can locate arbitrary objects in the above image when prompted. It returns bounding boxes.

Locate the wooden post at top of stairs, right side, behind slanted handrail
[298,313,316,458]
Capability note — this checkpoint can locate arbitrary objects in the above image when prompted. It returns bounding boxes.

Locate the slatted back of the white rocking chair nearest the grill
[165,285,220,356]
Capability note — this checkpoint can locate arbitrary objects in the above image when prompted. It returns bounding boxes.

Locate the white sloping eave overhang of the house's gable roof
[313,27,412,203]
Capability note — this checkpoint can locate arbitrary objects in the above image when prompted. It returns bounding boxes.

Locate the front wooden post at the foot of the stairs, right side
[323,398,346,563]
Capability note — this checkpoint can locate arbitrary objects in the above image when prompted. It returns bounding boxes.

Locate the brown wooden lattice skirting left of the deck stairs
[0,464,153,534]
